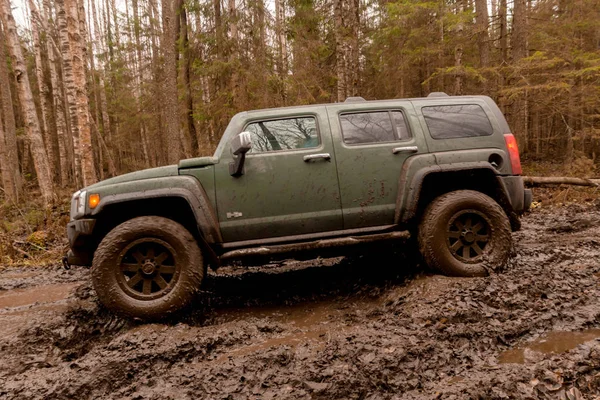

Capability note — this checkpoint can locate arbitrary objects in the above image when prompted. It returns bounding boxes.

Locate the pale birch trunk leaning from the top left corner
[0,0,54,206]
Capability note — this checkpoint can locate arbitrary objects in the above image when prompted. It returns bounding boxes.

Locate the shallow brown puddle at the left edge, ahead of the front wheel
[0,283,78,309]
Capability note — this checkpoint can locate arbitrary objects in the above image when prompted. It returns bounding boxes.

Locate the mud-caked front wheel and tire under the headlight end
[92,216,205,320]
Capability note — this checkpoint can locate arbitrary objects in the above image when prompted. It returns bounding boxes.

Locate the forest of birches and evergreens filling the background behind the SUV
[0,0,600,204]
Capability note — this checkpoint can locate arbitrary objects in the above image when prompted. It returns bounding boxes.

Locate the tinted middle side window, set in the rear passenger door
[340,111,411,144]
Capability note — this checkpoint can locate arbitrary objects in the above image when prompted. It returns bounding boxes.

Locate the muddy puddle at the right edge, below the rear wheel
[498,329,600,364]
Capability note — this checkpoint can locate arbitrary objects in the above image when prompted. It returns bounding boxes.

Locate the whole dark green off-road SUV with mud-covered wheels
[66,93,531,319]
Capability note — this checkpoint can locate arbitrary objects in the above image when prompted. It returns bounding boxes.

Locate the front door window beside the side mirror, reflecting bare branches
[245,117,319,153]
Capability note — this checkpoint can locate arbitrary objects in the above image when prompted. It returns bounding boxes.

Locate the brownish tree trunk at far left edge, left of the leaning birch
[0,22,22,201]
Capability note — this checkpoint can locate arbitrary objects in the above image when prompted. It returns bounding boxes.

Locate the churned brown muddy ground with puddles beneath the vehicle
[0,204,600,399]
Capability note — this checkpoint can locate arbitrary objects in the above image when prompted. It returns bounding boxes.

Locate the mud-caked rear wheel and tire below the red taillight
[418,190,512,276]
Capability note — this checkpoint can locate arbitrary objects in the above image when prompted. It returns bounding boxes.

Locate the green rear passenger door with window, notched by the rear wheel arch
[327,101,427,229]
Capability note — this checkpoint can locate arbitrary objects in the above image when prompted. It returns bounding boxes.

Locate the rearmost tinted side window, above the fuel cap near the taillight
[421,104,493,139]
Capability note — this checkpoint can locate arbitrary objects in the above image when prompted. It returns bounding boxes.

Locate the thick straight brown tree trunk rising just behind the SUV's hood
[161,1,181,164]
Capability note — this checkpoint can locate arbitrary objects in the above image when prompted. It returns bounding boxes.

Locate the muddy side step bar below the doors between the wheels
[219,231,410,260]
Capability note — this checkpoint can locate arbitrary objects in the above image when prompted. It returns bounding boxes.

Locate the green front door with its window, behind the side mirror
[215,107,343,242]
